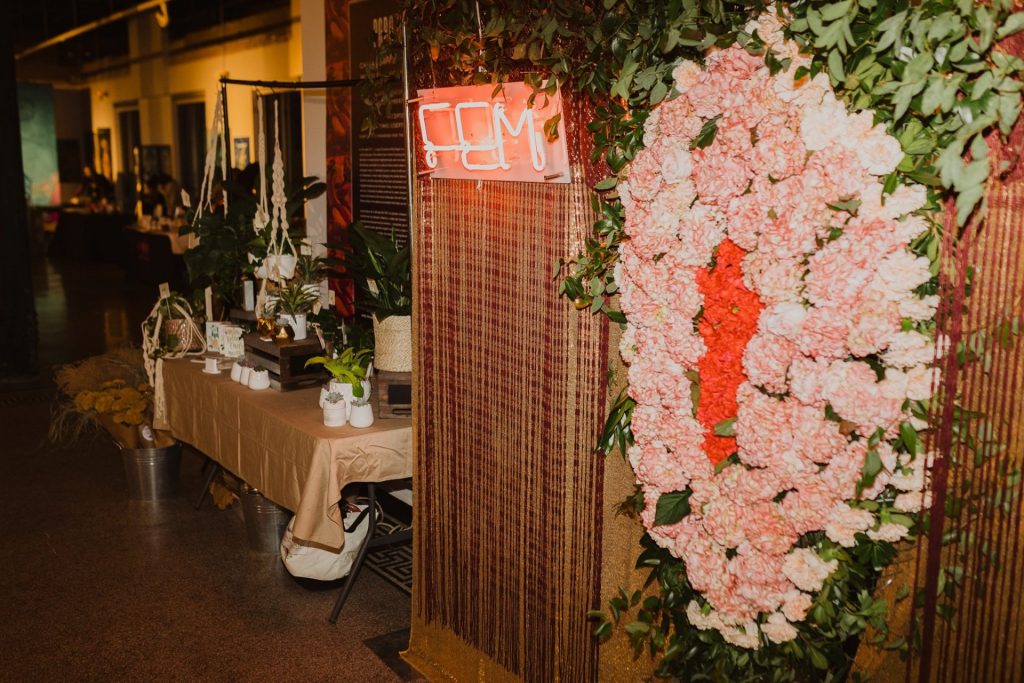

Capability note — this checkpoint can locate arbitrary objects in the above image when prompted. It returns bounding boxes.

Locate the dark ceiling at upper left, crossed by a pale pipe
[7,0,289,66]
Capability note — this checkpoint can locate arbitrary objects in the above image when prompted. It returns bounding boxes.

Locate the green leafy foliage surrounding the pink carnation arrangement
[380,0,1024,681]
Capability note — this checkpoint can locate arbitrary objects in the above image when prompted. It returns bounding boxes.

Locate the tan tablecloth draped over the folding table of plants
[162,359,413,549]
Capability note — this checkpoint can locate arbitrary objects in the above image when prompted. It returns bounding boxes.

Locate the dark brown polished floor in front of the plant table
[0,261,410,681]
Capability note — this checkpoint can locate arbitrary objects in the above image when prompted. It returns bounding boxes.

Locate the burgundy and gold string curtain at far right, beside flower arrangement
[919,152,1024,681]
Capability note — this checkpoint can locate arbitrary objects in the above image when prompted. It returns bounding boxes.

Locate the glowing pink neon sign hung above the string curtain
[417,83,571,182]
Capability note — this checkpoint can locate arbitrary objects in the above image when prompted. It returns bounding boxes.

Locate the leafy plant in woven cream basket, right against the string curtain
[345,222,413,373]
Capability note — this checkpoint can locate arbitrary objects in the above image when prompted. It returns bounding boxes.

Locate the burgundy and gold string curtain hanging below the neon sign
[404,172,608,681]
